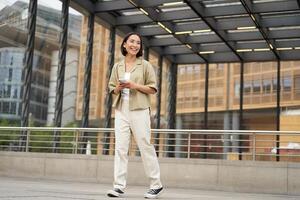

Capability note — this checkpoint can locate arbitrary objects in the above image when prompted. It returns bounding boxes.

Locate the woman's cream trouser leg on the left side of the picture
[114,107,130,190]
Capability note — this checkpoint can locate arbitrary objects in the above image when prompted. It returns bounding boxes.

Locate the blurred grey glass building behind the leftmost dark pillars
[0,1,81,124]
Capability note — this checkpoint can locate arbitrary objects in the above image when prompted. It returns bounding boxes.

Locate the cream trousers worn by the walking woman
[114,100,162,190]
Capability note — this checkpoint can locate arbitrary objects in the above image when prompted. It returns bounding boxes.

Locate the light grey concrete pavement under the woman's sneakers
[0,177,300,200]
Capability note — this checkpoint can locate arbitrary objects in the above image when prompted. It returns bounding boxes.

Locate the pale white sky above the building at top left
[0,0,80,15]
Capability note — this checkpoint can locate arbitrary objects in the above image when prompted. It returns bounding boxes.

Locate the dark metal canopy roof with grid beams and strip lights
[71,0,300,64]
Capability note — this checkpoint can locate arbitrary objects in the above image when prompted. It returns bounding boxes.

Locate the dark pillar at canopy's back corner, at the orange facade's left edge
[167,63,177,157]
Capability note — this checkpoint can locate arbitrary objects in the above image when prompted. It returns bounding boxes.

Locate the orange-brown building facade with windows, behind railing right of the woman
[176,61,299,160]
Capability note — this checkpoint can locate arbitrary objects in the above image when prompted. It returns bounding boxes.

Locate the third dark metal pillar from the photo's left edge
[80,13,95,153]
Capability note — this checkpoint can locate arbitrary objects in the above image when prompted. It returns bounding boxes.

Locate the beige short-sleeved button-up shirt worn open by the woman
[109,58,157,110]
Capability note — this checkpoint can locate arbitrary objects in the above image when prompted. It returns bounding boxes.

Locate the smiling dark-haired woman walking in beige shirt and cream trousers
[107,33,163,198]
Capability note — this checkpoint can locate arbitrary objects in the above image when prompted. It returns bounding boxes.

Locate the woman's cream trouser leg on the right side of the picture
[130,109,162,189]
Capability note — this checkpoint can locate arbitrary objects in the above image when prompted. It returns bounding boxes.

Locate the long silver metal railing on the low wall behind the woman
[0,127,300,162]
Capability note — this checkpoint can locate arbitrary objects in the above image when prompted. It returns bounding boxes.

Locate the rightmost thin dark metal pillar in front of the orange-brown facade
[276,60,281,161]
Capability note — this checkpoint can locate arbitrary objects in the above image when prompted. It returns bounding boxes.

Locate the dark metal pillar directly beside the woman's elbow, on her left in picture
[103,27,116,155]
